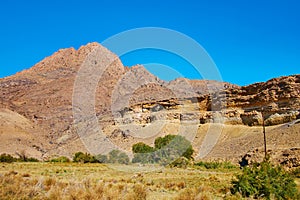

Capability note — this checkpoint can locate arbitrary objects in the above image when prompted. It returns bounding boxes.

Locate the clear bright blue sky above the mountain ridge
[0,0,300,85]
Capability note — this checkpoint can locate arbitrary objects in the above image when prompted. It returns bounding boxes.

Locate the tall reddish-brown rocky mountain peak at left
[0,43,125,157]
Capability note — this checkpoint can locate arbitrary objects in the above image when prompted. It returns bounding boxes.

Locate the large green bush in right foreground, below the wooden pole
[231,161,300,199]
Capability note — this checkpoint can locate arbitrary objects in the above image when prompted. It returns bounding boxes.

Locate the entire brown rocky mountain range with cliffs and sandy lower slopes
[0,43,300,167]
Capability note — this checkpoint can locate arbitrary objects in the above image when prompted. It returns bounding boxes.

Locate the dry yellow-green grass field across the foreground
[0,162,239,199]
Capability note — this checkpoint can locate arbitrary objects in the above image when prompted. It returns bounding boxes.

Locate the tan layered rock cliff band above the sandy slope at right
[119,75,300,126]
